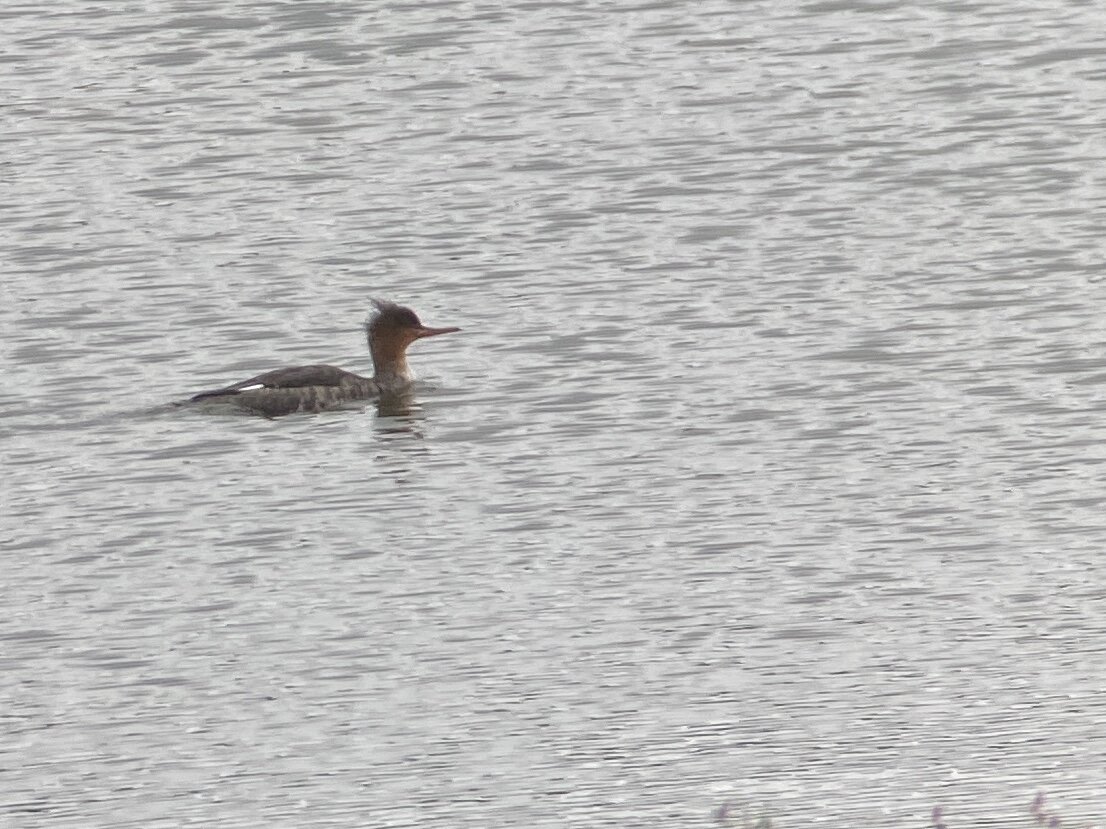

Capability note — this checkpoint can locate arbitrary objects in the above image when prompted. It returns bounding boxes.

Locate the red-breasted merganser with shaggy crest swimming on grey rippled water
[191,300,460,418]
